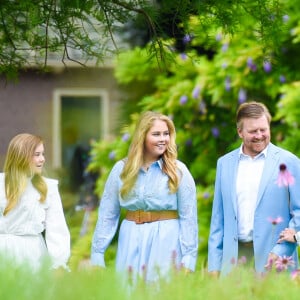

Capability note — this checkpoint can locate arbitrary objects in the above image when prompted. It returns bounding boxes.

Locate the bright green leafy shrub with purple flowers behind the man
[85,1,300,259]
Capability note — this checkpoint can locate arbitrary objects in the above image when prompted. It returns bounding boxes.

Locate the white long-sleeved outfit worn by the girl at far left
[0,173,70,270]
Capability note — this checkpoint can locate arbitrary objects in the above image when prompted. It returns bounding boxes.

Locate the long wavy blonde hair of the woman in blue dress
[120,111,179,198]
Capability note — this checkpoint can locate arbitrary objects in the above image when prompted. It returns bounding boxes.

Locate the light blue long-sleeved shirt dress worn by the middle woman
[91,160,198,281]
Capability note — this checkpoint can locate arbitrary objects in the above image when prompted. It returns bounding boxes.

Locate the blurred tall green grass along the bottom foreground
[0,263,300,300]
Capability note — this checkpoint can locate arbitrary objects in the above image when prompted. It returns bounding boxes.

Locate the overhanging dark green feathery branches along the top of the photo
[0,0,290,78]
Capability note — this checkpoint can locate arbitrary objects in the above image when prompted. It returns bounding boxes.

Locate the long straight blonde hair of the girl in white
[4,133,47,215]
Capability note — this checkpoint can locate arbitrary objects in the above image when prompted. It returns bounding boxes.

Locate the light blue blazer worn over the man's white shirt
[208,143,300,275]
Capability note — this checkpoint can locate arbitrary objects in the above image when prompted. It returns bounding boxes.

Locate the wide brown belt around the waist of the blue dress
[125,210,178,224]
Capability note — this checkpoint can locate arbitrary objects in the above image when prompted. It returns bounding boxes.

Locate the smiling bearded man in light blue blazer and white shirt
[208,102,300,276]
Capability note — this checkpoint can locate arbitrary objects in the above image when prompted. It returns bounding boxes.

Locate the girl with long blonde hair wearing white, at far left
[0,133,70,271]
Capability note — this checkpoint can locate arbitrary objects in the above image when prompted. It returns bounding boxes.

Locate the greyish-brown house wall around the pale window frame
[0,67,120,170]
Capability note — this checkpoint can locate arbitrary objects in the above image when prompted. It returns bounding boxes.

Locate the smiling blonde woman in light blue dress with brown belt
[91,111,198,281]
